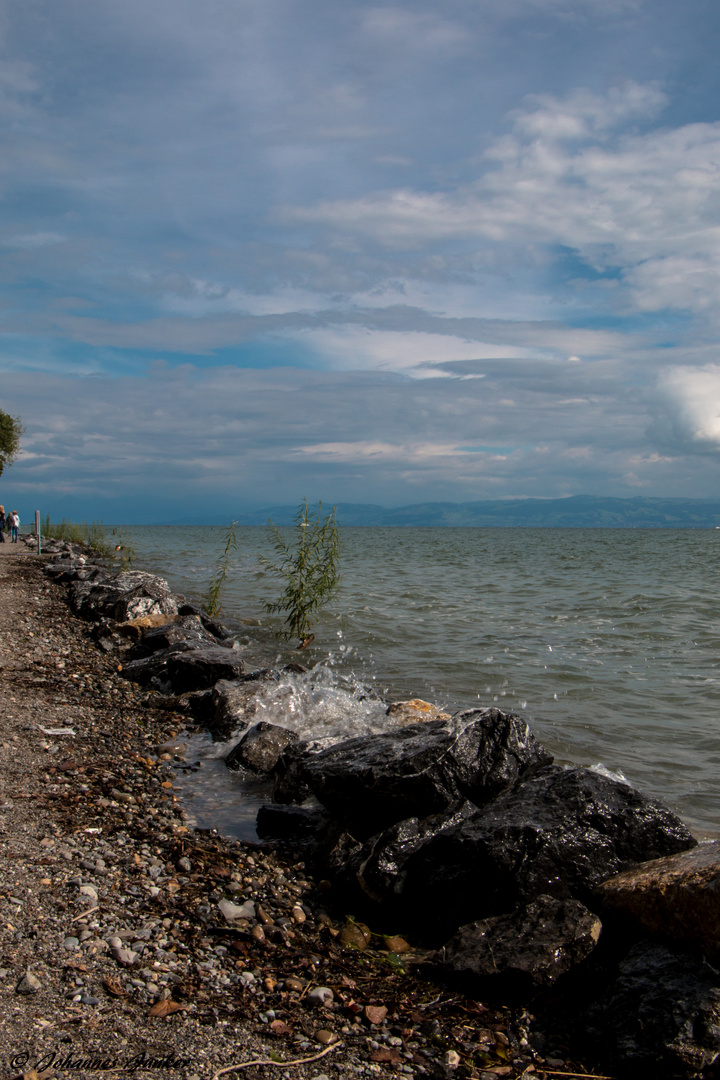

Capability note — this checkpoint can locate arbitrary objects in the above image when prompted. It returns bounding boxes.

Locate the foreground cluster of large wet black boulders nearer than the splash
[252,708,720,1077]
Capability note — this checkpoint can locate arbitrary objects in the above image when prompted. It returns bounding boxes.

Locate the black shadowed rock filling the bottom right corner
[579,942,720,1080]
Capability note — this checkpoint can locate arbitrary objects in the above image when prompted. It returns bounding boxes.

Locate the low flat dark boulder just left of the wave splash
[121,642,244,694]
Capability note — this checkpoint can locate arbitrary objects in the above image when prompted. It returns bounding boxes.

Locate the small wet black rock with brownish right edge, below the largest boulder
[434,895,602,1002]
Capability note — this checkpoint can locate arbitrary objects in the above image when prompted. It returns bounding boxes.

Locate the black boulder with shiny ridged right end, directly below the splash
[287,708,553,838]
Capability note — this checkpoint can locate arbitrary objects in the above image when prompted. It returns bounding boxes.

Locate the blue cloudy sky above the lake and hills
[0,0,720,522]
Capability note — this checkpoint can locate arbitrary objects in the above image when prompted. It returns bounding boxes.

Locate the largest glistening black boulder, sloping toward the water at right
[395,766,696,934]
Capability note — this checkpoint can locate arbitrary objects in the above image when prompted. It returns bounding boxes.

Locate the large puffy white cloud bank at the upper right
[285,83,720,312]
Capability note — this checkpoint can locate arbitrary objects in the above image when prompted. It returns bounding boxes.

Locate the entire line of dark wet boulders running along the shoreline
[40,540,720,1077]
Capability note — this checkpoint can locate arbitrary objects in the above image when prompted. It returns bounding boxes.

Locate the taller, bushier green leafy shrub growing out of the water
[262,499,340,642]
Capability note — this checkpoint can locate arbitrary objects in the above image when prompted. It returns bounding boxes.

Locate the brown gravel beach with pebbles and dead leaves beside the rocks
[0,541,590,1080]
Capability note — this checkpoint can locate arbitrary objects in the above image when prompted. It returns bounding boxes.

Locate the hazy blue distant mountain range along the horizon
[171,495,720,529]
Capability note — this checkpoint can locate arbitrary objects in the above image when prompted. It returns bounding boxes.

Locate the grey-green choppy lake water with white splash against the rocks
[119,526,720,836]
